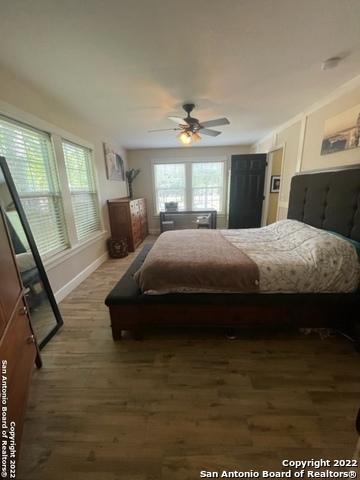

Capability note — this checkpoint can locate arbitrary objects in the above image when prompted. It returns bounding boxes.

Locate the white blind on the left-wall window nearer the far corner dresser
[62,140,101,241]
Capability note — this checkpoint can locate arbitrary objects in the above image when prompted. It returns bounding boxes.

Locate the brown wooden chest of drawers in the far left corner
[108,198,148,252]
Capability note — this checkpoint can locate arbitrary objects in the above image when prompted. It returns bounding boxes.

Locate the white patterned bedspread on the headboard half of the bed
[221,220,360,293]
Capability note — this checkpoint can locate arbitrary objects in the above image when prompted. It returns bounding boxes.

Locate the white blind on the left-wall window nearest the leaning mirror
[0,117,68,256]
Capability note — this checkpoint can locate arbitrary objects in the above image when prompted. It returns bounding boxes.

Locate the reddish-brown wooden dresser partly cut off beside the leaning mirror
[0,208,41,466]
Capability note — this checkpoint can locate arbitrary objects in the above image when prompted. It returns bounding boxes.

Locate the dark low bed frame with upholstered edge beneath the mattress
[105,245,360,340]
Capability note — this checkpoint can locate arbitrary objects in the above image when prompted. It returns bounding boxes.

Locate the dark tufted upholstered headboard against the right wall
[288,165,360,242]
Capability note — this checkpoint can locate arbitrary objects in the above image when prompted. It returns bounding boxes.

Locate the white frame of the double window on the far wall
[151,156,229,217]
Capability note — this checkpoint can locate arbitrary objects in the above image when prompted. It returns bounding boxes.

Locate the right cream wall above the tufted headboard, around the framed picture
[251,77,360,218]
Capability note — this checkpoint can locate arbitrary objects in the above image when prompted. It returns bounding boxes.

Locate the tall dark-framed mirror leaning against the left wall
[0,157,63,348]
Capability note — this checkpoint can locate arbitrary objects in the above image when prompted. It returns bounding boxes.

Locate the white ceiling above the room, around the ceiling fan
[0,0,360,148]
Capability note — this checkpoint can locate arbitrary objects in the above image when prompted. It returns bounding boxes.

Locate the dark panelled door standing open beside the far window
[229,153,266,228]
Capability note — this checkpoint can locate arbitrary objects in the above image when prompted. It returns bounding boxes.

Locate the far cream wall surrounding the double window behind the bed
[128,145,250,233]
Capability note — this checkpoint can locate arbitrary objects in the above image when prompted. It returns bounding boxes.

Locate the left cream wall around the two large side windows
[0,70,127,298]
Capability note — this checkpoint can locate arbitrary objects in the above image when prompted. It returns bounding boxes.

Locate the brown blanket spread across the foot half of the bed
[135,230,259,294]
